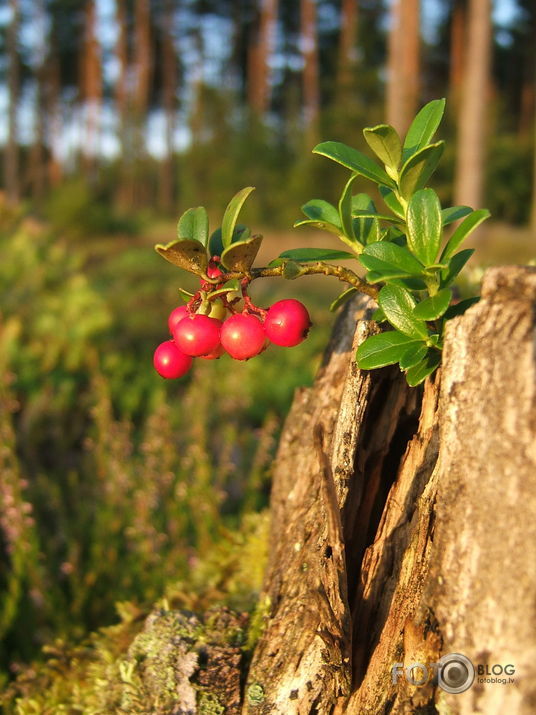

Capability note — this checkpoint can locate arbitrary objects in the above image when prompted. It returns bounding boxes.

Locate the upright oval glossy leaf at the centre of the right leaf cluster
[407,189,441,266]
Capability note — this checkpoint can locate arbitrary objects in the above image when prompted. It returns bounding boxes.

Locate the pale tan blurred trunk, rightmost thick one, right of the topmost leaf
[455,0,491,206]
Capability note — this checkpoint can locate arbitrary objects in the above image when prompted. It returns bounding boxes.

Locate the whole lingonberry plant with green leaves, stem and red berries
[155,99,489,386]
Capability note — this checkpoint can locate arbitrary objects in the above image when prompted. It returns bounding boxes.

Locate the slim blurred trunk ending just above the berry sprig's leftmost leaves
[159,0,177,211]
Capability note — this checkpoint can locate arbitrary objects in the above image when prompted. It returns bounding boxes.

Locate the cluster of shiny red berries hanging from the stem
[153,269,311,378]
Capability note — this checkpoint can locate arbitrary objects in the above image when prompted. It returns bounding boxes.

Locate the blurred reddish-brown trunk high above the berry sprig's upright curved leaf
[248,0,278,118]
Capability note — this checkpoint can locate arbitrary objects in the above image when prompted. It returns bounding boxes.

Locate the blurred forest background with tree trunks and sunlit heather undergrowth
[0,0,536,700]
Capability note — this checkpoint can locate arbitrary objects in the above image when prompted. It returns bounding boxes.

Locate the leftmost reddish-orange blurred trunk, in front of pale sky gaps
[80,0,102,181]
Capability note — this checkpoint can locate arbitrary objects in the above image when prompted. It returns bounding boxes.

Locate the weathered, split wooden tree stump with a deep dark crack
[243,267,536,715]
